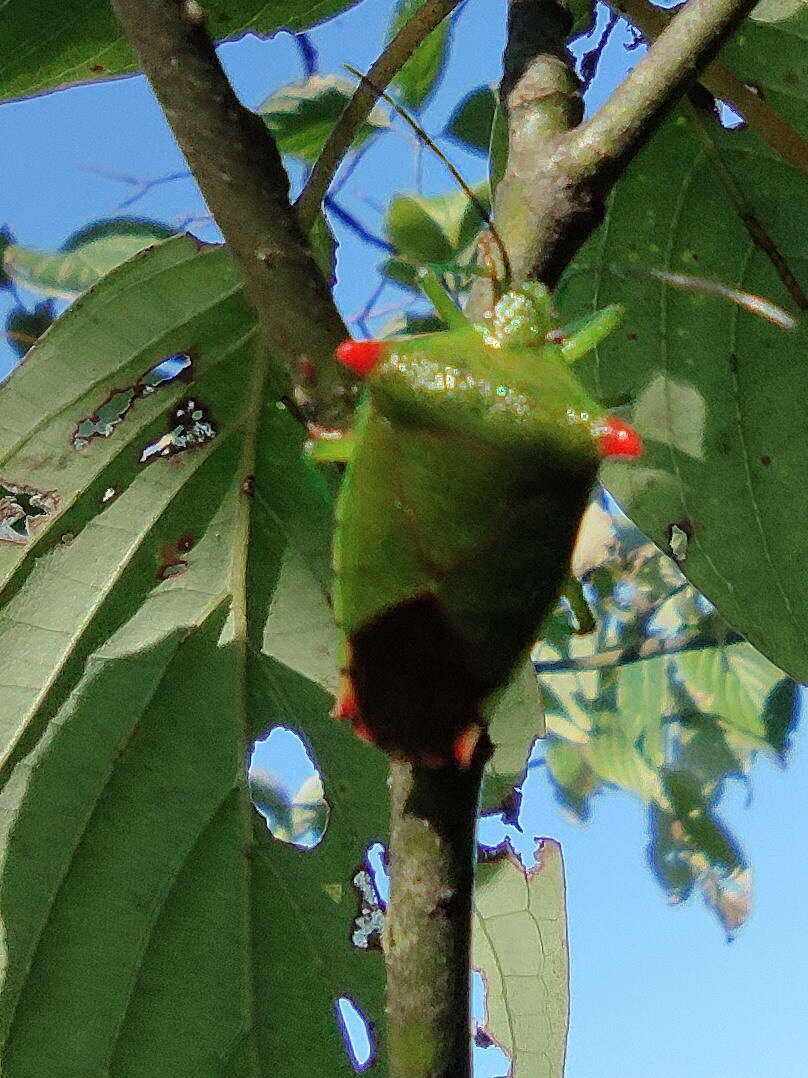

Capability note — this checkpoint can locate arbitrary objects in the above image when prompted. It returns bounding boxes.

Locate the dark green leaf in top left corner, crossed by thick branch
[0,0,364,99]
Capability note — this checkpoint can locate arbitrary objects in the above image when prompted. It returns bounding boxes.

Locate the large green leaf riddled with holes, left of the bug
[0,237,386,1078]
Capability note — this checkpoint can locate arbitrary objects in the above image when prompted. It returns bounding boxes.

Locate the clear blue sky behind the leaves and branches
[0,0,808,1078]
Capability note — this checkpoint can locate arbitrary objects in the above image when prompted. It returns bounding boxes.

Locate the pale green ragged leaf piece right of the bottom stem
[473,839,570,1078]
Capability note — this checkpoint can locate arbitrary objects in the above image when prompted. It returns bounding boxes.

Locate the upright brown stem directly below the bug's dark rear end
[384,750,487,1078]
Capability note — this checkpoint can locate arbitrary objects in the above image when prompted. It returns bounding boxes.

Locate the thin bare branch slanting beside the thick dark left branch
[295,0,460,229]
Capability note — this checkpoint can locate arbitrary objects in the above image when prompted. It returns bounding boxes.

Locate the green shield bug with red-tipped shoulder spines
[334,284,642,768]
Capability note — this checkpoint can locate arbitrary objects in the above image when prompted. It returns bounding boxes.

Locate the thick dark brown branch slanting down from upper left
[113,0,352,427]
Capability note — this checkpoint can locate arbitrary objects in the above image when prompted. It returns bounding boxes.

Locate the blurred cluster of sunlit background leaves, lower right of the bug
[537,514,799,931]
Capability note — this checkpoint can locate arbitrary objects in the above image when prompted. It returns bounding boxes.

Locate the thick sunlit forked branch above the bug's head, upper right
[473,0,754,306]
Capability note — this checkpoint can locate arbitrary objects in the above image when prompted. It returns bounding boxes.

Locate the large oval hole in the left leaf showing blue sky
[248,727,329,849]
